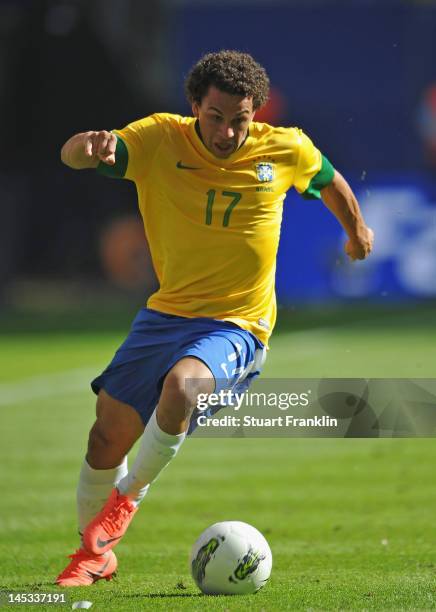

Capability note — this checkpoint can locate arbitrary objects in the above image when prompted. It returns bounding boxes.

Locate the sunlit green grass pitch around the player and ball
[0,311,436,612]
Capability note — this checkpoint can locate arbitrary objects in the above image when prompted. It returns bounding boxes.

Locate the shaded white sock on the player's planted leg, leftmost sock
[77,457,127,534]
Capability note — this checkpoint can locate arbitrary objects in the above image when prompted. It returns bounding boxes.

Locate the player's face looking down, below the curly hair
[192,86,254,158]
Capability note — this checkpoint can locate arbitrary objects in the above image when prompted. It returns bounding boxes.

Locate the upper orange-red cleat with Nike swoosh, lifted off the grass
[82,489,138,555]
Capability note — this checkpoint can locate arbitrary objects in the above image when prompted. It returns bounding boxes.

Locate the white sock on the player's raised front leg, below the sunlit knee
[118,410,186,504]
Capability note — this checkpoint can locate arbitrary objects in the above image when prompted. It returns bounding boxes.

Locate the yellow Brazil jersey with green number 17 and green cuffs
[99,113,333,344]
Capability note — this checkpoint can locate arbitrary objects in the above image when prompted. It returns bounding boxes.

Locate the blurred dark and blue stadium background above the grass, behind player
[0,0,436,327]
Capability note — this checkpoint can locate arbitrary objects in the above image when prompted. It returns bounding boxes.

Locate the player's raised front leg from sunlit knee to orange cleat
[83,357,215,554]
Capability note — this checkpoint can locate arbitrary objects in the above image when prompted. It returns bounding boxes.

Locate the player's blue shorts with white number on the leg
[91,308,265,433]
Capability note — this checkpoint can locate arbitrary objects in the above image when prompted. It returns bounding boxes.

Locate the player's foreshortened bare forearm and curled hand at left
[61,130,117,170]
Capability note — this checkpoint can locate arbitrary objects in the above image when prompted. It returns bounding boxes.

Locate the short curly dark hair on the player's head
[185,50,269,110]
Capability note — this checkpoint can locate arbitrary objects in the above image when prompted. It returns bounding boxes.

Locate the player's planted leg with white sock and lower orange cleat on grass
[56,390,144,587]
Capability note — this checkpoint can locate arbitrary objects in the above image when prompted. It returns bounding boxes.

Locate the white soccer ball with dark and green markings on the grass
[190,521,272,595]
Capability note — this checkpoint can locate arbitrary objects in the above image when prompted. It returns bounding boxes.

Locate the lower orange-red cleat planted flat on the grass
[56,548,118,587]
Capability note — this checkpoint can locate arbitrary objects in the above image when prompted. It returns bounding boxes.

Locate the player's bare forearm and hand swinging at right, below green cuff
[321,170,374,260]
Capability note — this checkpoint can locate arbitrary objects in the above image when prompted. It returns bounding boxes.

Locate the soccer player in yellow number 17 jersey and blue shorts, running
[57,51,373,586]
